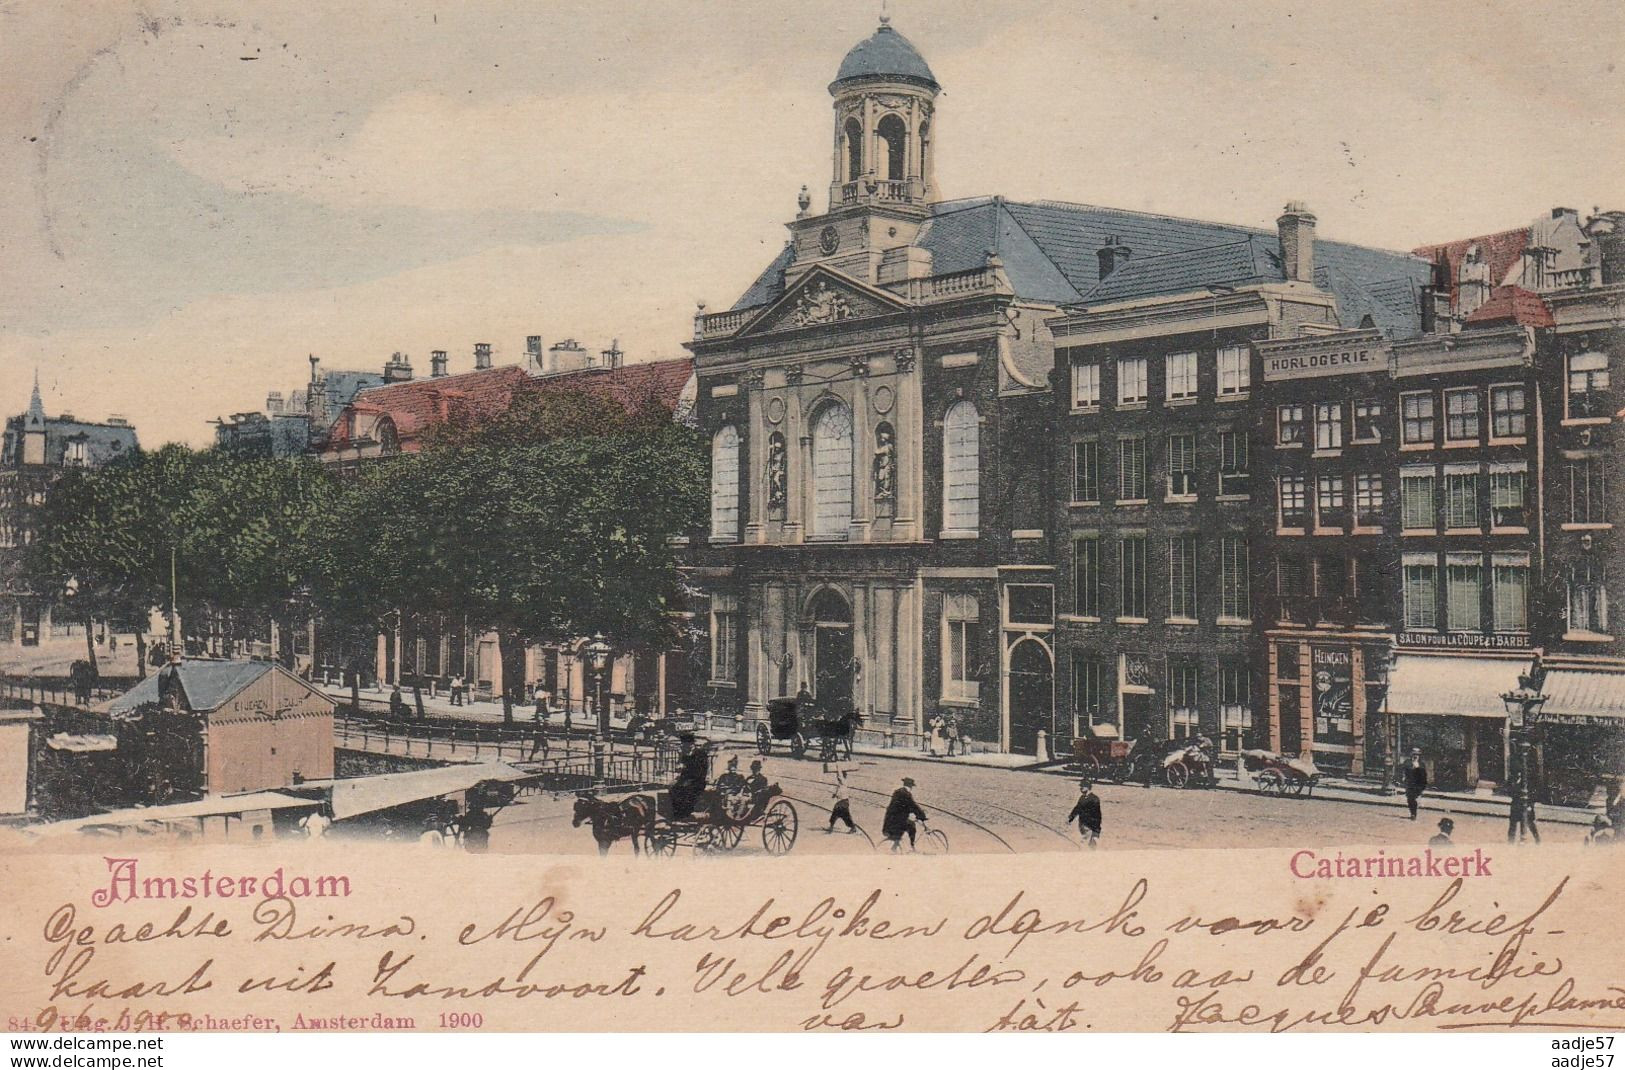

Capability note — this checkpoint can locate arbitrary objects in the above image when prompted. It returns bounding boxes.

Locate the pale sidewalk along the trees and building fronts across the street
[323,686,1597,828]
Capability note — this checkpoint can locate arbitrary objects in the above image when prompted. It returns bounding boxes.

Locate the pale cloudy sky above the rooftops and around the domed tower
[0,0,1625,446]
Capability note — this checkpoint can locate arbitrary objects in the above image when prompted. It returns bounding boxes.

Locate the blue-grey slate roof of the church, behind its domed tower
[733,197,1432,338]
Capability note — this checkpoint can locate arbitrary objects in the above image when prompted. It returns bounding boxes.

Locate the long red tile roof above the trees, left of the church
[325,358,694,452]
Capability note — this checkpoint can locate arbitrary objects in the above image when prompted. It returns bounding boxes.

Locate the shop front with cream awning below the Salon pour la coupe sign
[1386,652,1528,792]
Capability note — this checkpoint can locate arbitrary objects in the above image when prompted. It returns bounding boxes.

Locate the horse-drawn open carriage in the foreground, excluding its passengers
[572,784,801,855]
